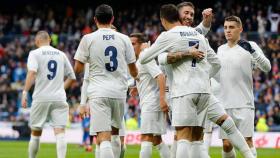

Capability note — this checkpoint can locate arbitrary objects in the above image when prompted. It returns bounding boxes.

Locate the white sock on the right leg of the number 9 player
[56,133,67,158]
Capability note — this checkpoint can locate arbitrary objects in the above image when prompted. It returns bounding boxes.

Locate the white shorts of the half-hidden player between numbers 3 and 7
[140,111,166,135]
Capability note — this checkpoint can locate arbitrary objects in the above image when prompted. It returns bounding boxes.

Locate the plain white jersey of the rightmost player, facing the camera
[217,42,271,109]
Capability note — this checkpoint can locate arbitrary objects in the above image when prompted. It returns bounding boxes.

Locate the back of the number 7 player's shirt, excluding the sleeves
[166,26,210,97]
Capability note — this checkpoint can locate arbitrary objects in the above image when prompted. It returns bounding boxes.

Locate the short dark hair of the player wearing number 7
[160,4,179,23]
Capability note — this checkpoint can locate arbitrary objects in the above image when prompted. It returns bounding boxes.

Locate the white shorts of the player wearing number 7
[172,94,211,127]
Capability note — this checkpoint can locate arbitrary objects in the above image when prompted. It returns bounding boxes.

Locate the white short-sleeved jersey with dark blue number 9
[27,46,76,102]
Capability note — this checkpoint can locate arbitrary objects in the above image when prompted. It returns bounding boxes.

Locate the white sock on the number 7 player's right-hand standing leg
[190,141,208,158]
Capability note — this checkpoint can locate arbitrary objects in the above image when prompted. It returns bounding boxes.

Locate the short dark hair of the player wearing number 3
[95,4,114,24]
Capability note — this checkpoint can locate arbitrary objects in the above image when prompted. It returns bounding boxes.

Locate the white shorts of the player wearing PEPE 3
[89,98,125,134]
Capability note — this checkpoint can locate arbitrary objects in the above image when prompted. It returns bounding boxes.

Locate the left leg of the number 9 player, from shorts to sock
[28,103,49,158]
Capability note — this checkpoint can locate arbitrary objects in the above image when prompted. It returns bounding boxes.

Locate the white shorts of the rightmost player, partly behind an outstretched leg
[220,108,255,139]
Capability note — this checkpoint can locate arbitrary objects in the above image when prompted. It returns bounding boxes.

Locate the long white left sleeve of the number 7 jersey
[139,32,172,64]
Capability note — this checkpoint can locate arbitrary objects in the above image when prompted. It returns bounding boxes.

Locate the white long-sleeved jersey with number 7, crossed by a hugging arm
[139,26,220,98]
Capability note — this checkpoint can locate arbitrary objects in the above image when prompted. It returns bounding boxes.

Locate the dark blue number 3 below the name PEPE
[105,46,118,72]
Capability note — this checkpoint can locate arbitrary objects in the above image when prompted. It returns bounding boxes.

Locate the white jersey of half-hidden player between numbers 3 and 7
[136,60,163,112]
